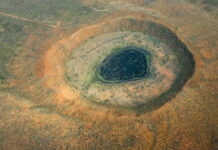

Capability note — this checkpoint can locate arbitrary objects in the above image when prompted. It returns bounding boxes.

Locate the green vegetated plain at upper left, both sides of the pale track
[0,0,99,79]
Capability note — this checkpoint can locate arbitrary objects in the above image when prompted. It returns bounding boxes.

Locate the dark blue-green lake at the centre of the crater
[99,47,148,83]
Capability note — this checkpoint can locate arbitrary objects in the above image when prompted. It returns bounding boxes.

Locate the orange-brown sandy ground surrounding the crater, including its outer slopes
[0,0,218,150]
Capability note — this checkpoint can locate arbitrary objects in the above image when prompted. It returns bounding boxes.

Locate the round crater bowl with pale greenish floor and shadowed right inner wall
[66,18,195,112]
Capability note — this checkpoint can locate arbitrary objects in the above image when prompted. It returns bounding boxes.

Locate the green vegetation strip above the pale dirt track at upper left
[0,0,98,23]
